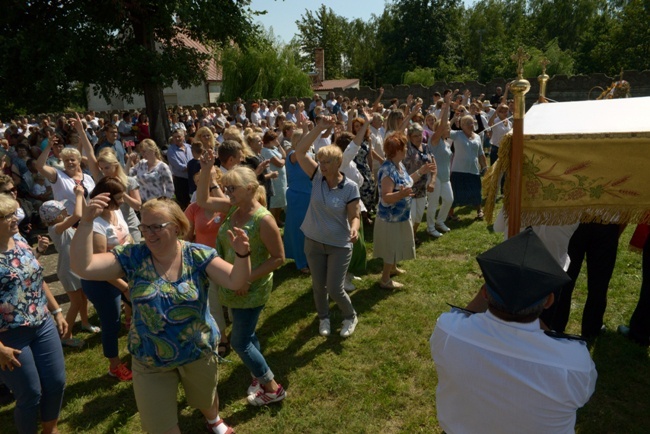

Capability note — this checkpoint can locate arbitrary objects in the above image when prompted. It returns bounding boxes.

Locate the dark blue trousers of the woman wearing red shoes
[81,279,122,359]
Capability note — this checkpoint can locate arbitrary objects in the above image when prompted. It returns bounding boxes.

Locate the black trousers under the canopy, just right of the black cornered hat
[541,223,616,337]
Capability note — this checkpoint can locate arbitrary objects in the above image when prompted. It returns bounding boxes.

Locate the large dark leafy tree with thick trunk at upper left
[0,0,254,143]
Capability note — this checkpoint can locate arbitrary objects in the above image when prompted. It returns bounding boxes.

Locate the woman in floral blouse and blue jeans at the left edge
[0,194,68,434]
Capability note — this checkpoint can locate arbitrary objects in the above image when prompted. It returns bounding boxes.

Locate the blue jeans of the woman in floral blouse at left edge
[0,317,65,434]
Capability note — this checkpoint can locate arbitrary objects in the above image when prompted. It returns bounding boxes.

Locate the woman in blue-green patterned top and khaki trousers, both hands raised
[71,193,250,434]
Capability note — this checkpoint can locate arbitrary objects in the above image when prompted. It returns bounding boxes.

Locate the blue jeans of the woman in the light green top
[230,306,273,384]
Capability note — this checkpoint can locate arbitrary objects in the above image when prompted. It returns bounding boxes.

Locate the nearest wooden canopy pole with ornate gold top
[508,47,530,237]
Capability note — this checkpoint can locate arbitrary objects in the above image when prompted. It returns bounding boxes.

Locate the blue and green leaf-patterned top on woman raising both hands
[112,241,220,368]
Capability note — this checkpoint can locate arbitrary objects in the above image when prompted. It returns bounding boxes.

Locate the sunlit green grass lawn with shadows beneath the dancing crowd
[0,205,650,434]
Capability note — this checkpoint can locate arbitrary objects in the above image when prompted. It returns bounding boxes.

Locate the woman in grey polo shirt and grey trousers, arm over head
[296,117,360,337]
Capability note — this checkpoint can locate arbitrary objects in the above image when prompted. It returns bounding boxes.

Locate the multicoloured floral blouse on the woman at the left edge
[0,234,49,330]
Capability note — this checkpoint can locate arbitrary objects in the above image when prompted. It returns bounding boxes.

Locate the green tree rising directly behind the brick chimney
[295,5,350,79]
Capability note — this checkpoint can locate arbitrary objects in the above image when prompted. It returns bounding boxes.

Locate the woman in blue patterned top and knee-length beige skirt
[373,133,436,289]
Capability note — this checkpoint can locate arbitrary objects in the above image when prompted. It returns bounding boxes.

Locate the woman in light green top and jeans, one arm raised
[196,155,286,406]
